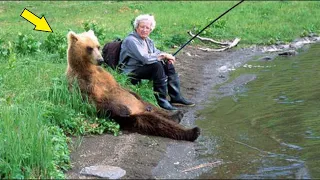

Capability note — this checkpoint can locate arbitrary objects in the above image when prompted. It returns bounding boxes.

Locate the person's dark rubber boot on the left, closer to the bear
[153,79,178,110]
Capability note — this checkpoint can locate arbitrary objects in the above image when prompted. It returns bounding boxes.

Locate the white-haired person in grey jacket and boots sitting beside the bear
[119,14,195,110]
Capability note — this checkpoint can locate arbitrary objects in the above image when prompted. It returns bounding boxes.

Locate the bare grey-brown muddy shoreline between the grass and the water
[66,35,318,179]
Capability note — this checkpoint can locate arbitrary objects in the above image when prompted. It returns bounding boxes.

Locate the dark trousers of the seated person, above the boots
[129,61,176,84]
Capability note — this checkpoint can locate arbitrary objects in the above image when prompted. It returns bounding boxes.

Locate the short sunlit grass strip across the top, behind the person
[0,1,320,45]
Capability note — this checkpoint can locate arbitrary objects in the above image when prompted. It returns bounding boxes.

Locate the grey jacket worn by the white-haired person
[119,31,161,74]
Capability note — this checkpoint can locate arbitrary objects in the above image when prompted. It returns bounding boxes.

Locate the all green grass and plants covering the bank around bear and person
[0,1,320,178]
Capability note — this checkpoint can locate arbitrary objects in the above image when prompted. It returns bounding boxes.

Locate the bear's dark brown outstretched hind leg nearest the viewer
[132,113,200,141]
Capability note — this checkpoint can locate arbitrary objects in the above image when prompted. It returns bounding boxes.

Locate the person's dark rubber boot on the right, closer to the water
[168,74,195,106]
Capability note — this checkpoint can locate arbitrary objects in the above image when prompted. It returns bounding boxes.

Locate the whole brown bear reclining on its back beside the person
[66,30,200,141]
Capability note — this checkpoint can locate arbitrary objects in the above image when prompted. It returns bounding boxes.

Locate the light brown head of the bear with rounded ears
[68,30,103,65]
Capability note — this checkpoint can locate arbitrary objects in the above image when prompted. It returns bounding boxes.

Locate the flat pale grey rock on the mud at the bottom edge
[80,165,126,179]
